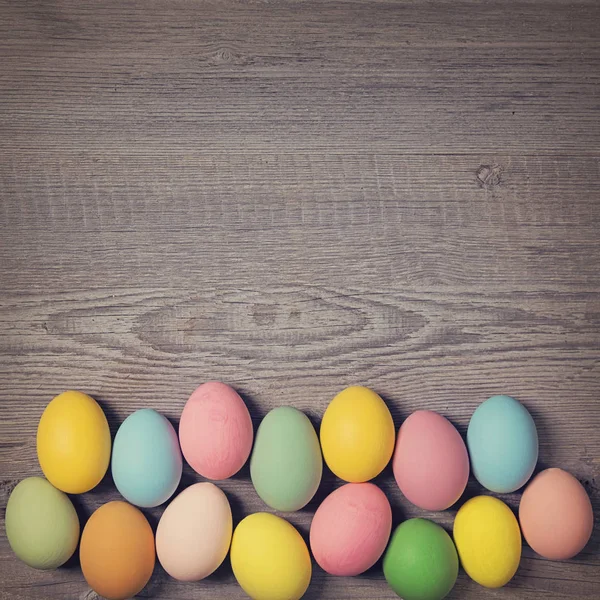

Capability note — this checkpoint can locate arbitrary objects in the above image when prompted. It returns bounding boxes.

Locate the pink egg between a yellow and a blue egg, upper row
[392,410,469,510]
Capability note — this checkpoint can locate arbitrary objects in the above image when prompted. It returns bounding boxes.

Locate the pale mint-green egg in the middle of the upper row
[250,406,323,511]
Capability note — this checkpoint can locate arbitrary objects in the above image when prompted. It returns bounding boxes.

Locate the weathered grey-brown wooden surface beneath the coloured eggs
[0,0,600,600]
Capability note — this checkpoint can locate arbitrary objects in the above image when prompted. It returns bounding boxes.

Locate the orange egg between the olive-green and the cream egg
[79,502,154,600]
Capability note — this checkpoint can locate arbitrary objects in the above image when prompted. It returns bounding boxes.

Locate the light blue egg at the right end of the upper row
[467,396,538,494]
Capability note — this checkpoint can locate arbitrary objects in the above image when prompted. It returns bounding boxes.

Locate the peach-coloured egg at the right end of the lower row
[519,469,594,560]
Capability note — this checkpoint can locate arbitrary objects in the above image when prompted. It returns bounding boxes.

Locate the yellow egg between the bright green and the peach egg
[454,496,521,588]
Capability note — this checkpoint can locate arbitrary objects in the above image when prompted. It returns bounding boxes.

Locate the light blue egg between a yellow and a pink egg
[111,408,183,508]
